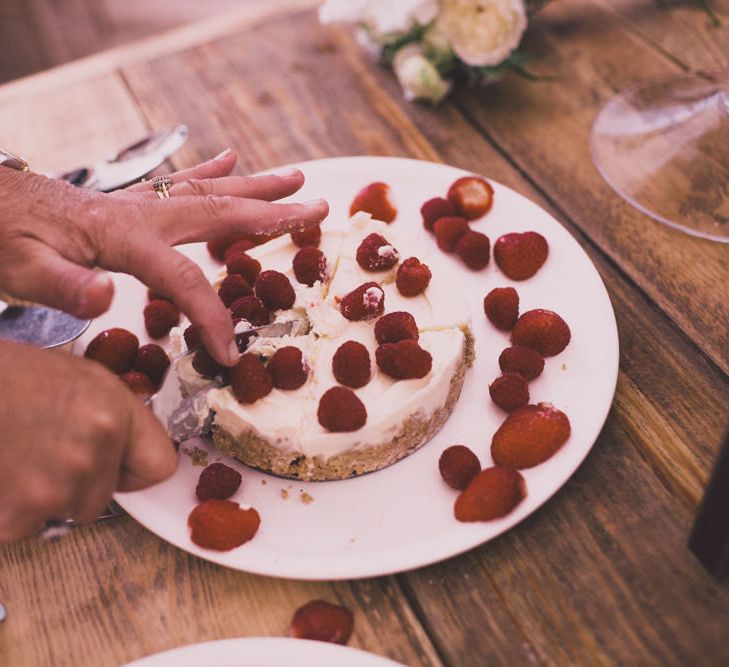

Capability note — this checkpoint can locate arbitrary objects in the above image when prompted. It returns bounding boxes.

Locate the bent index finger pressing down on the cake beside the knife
[109,236,239,366]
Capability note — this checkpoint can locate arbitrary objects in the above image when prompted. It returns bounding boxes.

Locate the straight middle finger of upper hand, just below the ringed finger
[149,195,329,245]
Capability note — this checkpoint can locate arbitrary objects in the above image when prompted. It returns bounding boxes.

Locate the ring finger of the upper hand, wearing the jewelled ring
[135,169,304,201]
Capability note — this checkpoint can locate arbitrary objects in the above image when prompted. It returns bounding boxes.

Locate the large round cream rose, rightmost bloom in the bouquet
[436,0,527,66]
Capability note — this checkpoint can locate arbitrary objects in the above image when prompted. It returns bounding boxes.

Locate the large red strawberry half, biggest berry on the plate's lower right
[491,403,571,468]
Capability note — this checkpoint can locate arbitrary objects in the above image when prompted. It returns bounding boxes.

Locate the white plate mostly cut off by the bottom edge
[125,637,403,667]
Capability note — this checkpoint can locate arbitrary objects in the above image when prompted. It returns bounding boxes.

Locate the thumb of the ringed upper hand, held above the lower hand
[3,245,114,319]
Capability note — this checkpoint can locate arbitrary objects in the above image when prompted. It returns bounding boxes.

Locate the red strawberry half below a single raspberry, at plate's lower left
[187,499,261,551]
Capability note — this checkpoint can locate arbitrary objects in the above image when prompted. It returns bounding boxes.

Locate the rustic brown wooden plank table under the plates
[0,0,729,666]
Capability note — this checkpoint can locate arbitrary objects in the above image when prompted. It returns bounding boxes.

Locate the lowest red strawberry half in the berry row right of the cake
[453,466,526,521]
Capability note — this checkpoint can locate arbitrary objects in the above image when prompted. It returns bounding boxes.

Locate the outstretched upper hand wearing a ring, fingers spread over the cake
[0,151,328,366]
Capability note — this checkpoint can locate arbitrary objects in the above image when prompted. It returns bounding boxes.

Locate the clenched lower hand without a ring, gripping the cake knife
[0,341,177,543]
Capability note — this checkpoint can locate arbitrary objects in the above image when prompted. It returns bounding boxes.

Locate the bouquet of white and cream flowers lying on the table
[319,0,546,104]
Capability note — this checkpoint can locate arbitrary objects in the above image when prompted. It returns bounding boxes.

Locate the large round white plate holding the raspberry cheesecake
[89,157,618,579]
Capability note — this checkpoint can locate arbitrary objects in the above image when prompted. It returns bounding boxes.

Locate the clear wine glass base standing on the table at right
[590,71,729,243]
